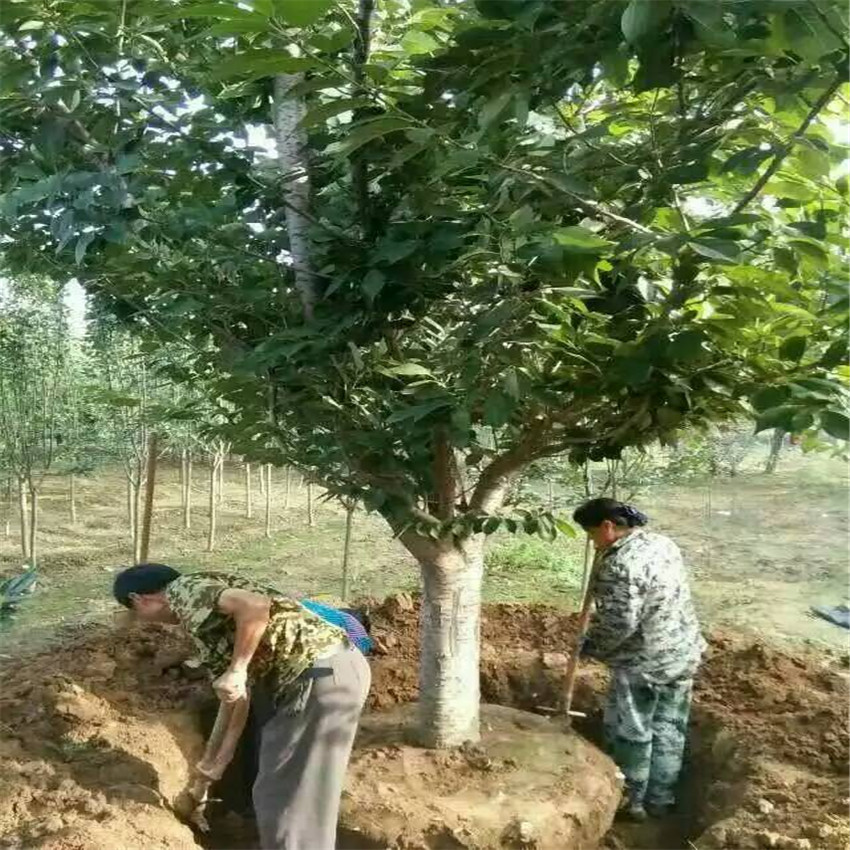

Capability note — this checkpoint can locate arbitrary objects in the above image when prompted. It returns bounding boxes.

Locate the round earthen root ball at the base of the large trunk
[340,706,622,850]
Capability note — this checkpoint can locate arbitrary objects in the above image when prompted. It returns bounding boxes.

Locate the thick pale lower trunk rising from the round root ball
[413,540,484,747]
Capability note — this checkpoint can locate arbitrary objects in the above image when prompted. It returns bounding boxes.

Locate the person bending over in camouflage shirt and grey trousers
[114,564,370,850]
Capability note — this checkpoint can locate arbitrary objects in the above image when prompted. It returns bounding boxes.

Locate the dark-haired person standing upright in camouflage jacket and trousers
[573,499,706,821]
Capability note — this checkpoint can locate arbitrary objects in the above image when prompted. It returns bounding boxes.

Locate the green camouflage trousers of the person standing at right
[605,670,693,806]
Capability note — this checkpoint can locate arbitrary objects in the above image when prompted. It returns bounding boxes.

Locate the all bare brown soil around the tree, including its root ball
[0,596,850,850]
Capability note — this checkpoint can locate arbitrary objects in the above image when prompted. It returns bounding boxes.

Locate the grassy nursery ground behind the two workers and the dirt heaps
[0,448,848,652]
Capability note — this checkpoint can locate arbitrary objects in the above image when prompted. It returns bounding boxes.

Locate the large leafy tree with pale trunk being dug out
[0,0,848,745]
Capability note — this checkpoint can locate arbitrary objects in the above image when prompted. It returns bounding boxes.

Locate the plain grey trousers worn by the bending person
[253,649,371,850]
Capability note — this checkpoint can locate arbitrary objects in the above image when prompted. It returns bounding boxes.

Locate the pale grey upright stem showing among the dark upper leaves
[272,74,316,322]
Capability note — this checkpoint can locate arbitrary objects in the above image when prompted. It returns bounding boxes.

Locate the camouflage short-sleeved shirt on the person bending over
[165,572,348,700]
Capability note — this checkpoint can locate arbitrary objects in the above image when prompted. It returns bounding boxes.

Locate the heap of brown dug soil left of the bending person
[0,616,204,850]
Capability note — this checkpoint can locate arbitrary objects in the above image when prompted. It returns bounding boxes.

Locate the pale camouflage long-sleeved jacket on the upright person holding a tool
[583,529,706,684]
